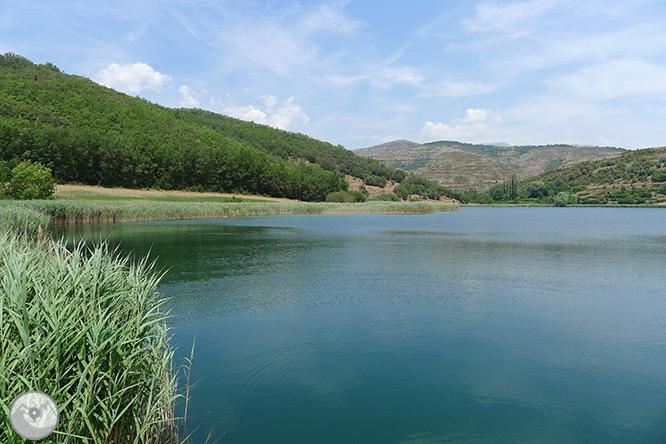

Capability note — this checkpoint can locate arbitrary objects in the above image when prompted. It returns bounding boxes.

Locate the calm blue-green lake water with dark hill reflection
[55,208,666,444]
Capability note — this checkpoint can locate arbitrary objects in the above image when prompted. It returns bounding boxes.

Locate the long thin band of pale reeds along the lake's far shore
[0,200,458,224]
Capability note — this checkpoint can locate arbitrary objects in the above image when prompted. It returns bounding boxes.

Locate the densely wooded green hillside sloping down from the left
[0,54,446,201]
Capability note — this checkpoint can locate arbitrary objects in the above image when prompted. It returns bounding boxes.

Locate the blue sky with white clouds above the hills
[0,0,666,149]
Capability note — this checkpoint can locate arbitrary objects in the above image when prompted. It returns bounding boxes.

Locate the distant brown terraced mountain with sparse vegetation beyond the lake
[354,140,625,191]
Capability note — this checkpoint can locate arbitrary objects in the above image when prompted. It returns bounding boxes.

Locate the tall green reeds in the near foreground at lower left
[0,232,180,444]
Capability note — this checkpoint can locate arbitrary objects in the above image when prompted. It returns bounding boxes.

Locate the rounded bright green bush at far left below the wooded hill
[7,160,55,199]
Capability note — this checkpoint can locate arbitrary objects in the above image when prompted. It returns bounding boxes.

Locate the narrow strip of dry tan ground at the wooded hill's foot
[55,185,296,202]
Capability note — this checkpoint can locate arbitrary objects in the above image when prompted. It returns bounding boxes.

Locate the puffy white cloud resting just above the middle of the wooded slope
[218,95,310,130]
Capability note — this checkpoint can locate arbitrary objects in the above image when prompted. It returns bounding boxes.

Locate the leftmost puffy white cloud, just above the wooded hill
[94,63,171,94]
